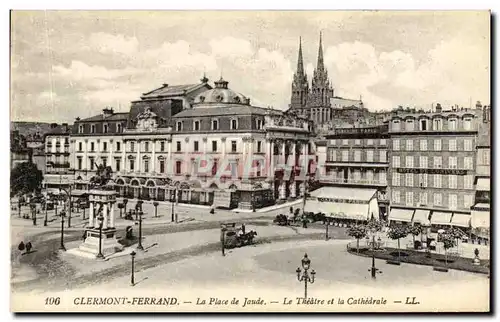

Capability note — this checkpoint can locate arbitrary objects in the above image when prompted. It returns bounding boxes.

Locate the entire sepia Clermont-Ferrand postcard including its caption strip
[10,10,492,312]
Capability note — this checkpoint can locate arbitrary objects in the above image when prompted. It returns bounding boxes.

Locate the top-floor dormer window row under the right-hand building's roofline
[391,117,472,132]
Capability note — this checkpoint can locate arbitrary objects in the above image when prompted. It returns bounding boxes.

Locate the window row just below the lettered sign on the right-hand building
[392,172,474,189]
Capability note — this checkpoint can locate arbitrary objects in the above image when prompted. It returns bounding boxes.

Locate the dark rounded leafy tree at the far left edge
[10,162,43,196]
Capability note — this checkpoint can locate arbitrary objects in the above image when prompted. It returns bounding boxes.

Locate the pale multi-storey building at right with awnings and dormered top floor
[389,104,478,229]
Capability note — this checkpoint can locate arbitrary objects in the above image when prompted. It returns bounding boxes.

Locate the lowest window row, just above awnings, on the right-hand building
[392,190,474,210]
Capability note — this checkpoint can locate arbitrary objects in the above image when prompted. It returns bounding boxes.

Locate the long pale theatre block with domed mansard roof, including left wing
[71,77,313,209]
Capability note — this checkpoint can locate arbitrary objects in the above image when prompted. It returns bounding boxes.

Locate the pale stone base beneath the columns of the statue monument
[78,228,124,257]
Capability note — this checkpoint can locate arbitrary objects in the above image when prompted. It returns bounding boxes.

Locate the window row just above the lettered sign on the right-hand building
[392,155,474,170]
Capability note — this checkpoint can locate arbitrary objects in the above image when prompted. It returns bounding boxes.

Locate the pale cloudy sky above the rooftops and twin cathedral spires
[10,11,490,123]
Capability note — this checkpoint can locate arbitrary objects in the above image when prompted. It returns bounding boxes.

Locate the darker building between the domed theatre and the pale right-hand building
[317,125,389,219]
